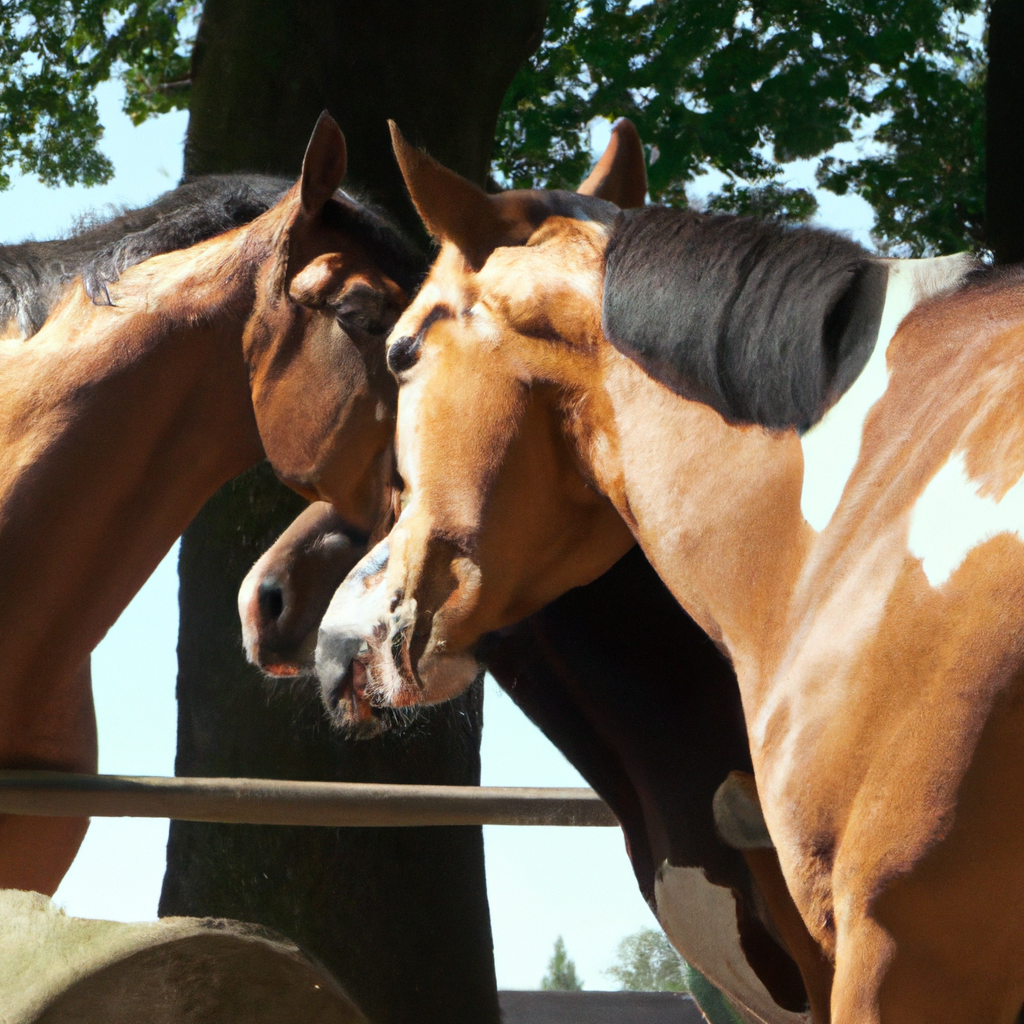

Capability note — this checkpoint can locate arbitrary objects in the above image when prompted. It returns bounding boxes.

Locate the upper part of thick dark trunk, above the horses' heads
[185,0,548,232]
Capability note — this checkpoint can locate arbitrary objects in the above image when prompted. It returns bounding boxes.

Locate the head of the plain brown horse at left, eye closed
[244,113,422,529]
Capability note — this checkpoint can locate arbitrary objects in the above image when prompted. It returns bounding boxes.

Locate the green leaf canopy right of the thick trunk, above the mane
[496,0,984,255]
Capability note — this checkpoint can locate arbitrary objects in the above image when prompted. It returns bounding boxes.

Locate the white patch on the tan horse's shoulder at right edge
[907,453,1024,588]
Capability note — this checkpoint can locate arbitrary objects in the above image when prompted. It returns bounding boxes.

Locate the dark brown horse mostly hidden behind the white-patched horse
[239,503,830,1024]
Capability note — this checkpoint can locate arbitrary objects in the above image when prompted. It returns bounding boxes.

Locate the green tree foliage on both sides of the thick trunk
[0,0,985,255]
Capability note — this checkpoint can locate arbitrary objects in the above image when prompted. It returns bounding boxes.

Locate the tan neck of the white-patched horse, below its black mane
[574,345,814,706]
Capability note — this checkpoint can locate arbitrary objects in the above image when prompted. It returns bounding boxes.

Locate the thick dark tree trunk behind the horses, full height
[160,0,547,1024]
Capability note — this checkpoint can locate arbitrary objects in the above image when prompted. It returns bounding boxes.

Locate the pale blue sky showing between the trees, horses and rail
[0,77,872,989]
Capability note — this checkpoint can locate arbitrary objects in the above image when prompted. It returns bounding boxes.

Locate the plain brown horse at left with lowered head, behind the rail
[0,116,420,893]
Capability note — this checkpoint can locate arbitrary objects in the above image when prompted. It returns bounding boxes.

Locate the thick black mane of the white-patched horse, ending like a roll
[602,206,888,430]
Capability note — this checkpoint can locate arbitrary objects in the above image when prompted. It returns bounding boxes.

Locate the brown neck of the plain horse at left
[0,234,262,677]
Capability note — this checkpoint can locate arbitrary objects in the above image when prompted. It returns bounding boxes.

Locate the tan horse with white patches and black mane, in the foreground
[317,123,1024,1024]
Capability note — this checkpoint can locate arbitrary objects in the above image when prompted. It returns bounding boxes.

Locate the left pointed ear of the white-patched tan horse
[388,121,505,269]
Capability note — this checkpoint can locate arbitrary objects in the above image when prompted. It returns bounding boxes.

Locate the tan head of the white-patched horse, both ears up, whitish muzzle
[317,122,646,706]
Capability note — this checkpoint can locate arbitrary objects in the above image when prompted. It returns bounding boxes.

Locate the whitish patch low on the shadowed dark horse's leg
[654,861,810,1024]
